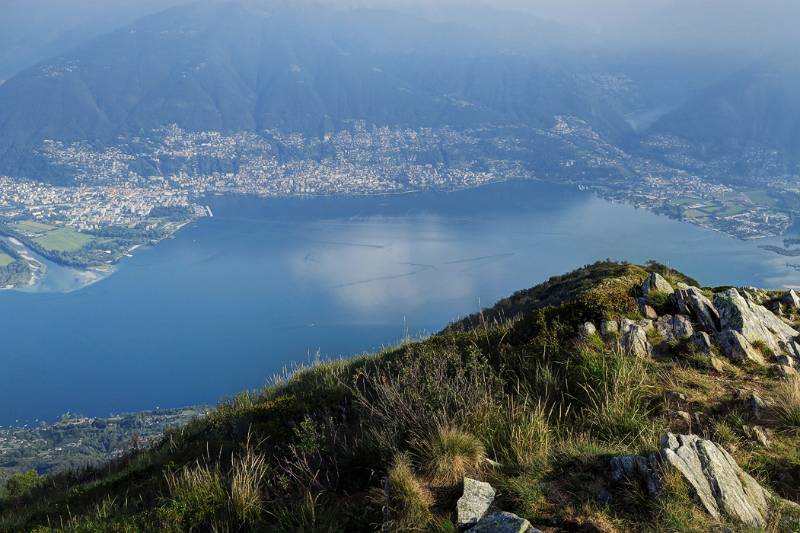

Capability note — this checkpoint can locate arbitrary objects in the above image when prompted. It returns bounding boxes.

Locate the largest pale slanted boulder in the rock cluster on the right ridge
[714,289,800,354]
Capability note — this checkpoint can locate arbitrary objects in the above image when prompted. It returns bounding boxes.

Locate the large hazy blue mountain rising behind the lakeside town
[0,0,629,179]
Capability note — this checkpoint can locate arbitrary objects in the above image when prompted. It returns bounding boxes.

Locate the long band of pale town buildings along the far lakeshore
[0,117,796,244]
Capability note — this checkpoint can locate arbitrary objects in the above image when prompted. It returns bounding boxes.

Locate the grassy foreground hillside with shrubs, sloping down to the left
[0,261,800,532]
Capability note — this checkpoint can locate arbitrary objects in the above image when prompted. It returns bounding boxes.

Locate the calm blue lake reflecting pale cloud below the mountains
[0,182,800,424]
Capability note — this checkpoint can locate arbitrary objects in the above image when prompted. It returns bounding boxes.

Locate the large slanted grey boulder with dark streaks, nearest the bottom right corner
[661,433,769,528]
